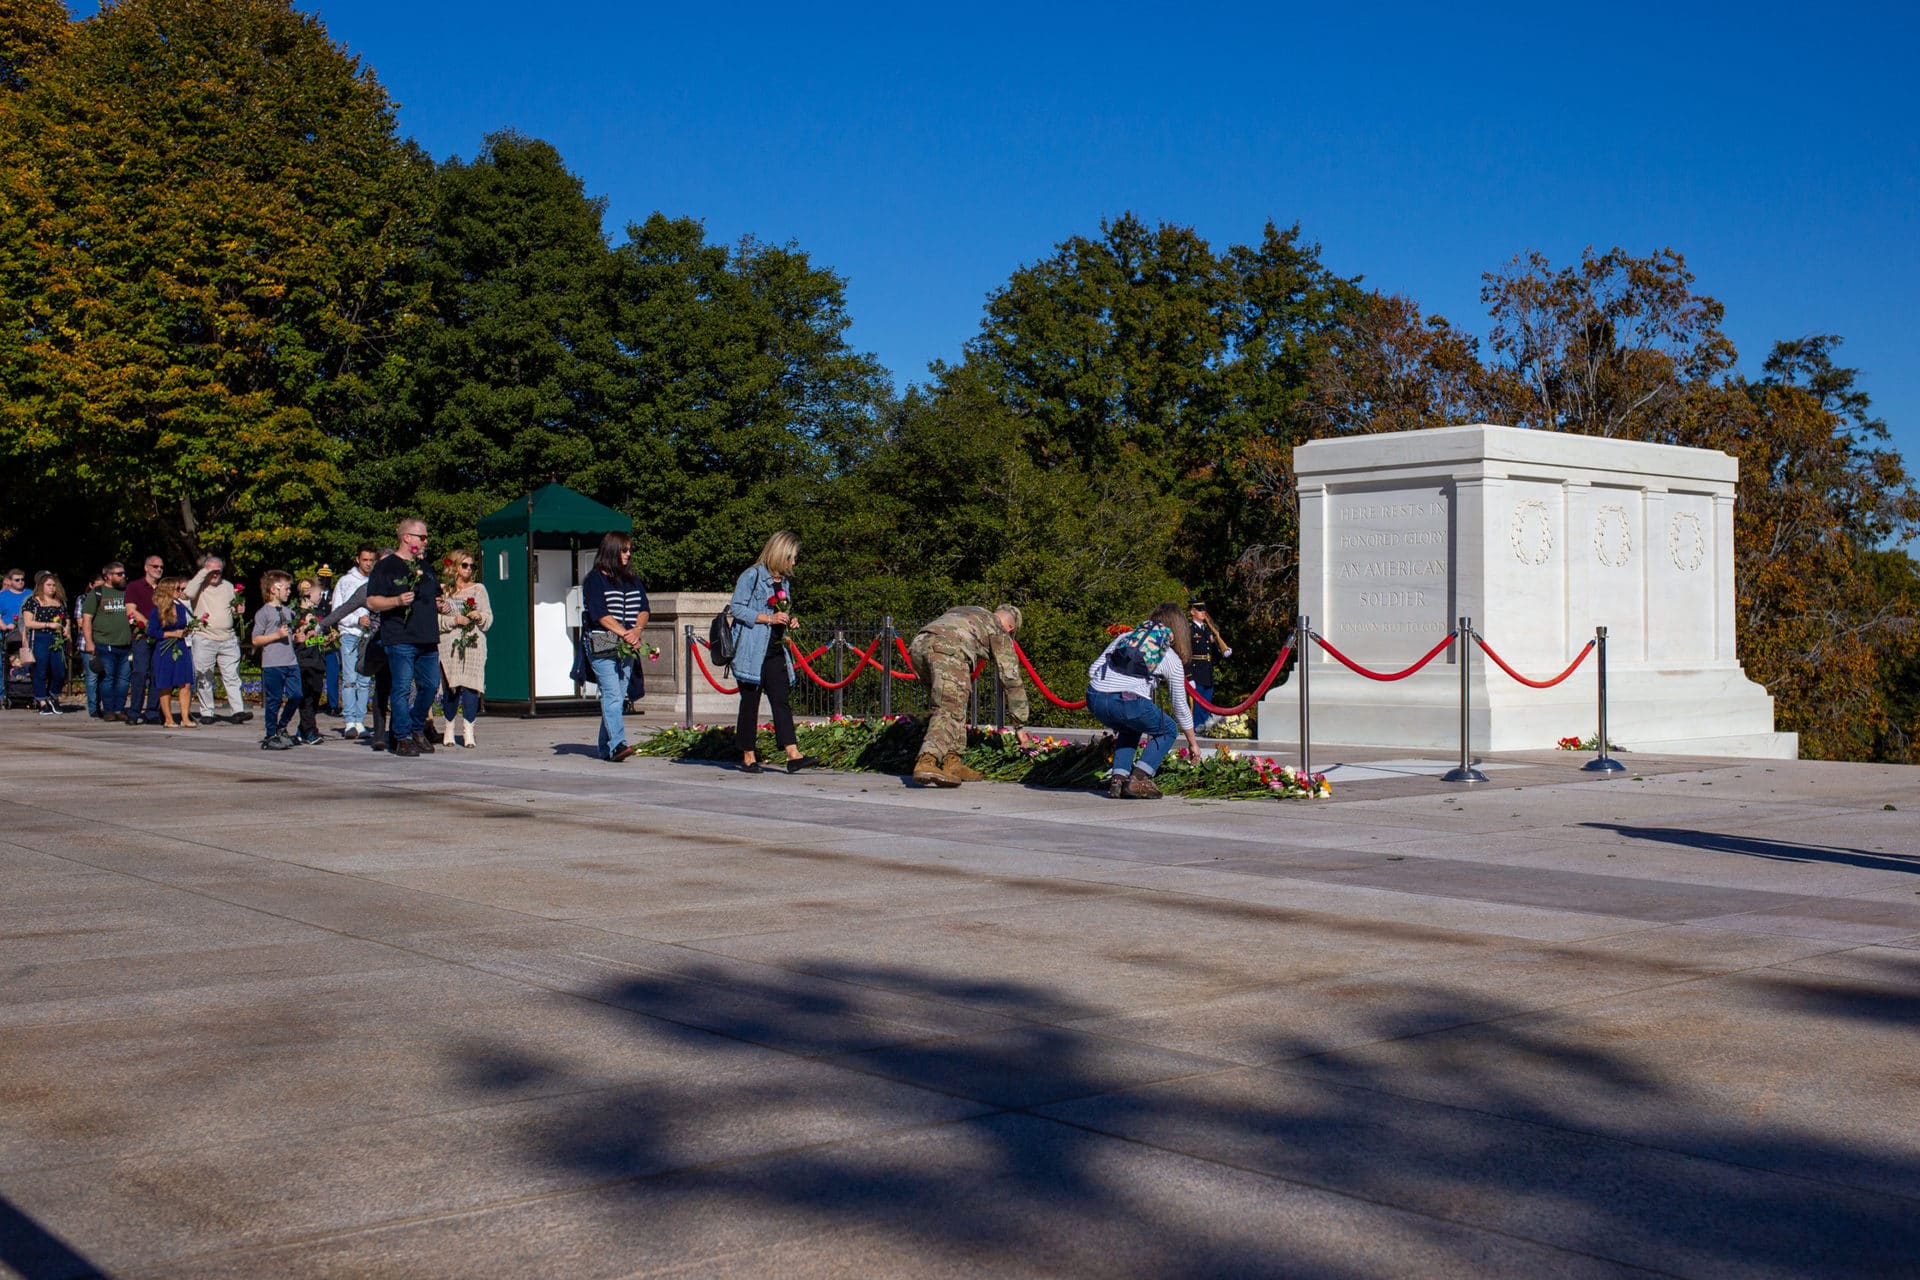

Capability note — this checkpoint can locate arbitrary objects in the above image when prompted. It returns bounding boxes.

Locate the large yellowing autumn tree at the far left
[0,0,420,562]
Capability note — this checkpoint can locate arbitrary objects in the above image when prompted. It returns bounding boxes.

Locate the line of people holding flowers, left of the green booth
[0,520,493,756]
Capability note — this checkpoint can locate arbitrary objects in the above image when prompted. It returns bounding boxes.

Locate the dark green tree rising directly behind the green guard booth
[342,132,624,543]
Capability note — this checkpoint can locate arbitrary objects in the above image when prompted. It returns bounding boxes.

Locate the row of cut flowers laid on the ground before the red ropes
[639,716,1332,800]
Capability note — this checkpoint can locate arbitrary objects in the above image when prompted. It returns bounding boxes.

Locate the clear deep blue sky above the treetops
[75,0,1920,475]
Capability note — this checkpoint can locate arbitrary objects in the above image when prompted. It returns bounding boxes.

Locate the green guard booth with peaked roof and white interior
[480,484,634,714]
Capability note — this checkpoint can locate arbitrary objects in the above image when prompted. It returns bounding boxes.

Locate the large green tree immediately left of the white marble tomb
[935,215,1363,689]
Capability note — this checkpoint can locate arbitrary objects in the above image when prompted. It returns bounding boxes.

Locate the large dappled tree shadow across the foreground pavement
[445,963,1920,1276]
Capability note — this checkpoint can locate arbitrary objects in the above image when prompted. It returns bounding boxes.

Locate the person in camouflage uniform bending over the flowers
[908,604,1029,787]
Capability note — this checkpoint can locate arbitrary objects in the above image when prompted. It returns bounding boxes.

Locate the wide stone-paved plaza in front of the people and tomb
[0,714,1920,1278]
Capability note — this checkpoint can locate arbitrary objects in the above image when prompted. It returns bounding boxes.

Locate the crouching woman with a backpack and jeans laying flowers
[1087,604,1200,800]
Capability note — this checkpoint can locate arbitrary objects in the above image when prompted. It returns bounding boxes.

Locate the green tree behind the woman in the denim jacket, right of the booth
[586,213,891,589]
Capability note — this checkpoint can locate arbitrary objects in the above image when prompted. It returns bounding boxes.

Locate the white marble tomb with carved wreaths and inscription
[1260,424,1797,758]
